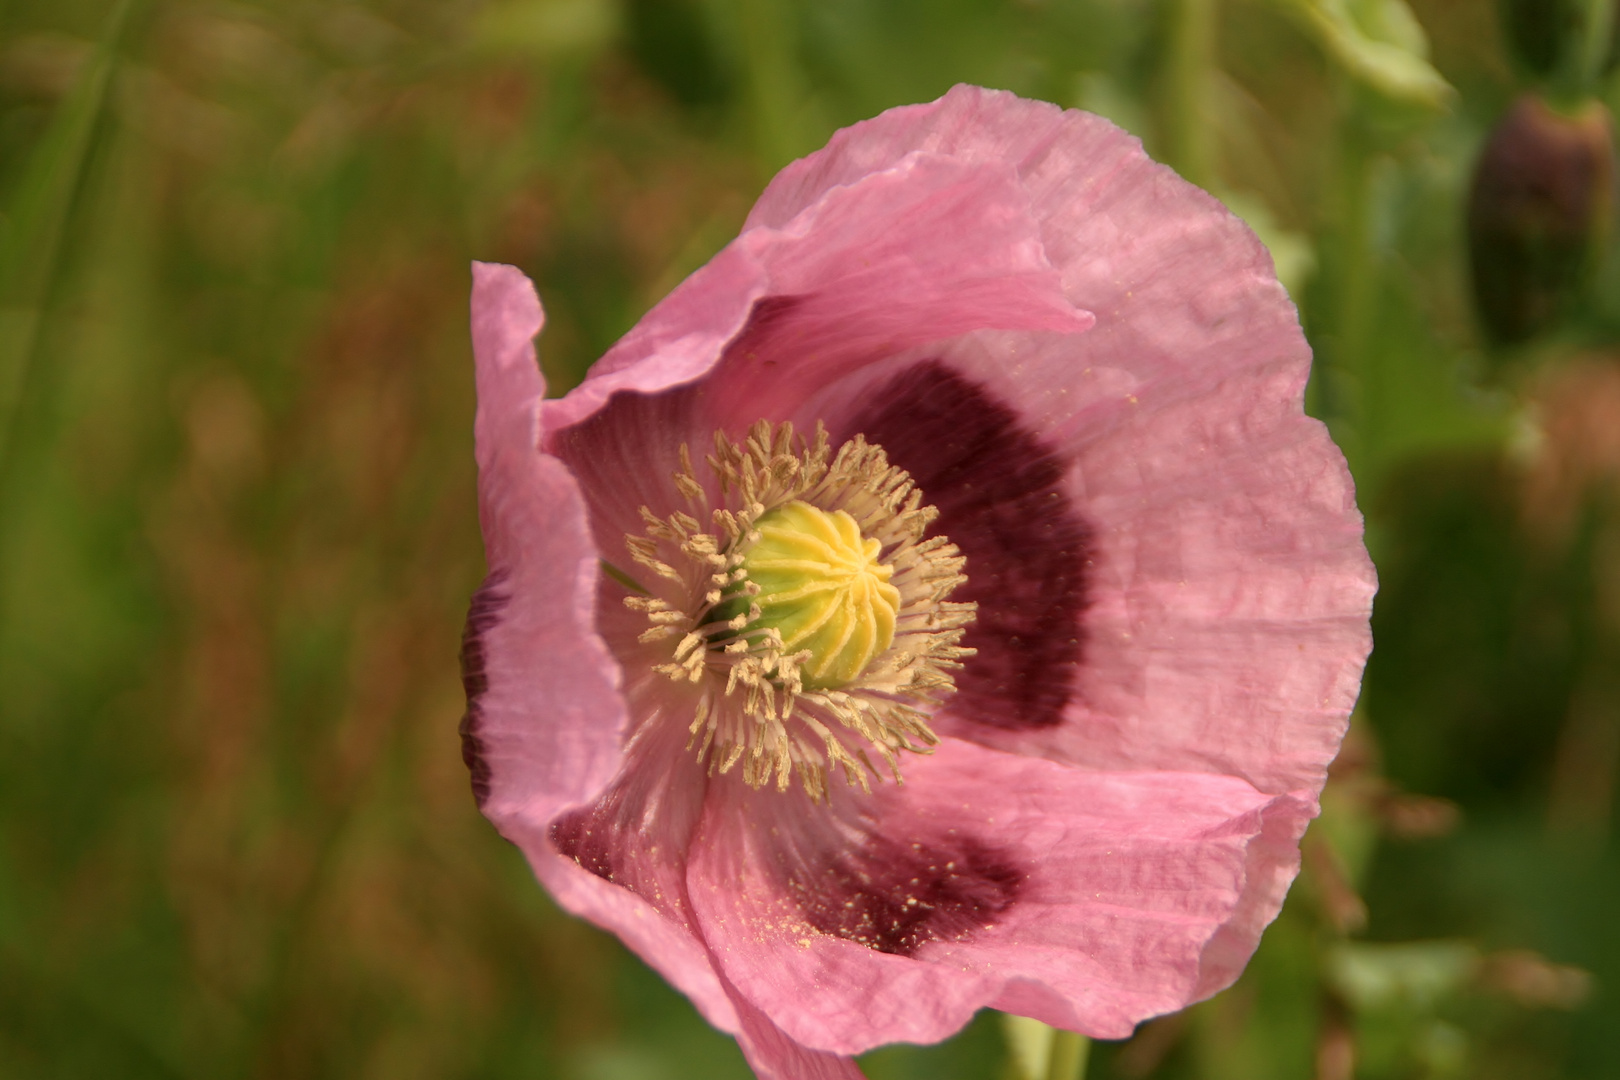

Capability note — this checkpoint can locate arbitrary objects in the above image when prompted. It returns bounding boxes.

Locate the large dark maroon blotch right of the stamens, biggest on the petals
[849,361,1092,729]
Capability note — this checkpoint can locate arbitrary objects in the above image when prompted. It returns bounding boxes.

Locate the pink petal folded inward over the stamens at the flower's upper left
[543,148,1092,552]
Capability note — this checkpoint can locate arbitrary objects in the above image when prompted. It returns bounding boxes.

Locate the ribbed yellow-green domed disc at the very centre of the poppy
[742,500,901,690]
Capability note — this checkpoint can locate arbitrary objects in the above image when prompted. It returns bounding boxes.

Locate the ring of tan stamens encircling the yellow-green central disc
[625,421,977,800]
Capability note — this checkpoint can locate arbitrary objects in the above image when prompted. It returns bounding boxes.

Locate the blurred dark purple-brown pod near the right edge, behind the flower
[1468,94,1614,343]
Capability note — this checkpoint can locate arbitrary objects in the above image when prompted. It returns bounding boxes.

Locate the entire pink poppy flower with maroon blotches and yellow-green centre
[462,86,1374,1078]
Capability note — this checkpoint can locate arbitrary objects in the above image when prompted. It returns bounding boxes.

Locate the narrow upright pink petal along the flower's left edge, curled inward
[463,264,737,1031]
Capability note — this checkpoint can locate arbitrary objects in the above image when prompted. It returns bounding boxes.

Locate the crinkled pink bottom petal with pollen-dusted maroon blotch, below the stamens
[689,740,1315,1054]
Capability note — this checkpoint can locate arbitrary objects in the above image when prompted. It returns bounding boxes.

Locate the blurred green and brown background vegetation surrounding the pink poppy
[0,0,1620,1080]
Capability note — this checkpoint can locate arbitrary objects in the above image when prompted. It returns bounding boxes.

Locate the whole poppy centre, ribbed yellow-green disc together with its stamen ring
[625,421,975,800]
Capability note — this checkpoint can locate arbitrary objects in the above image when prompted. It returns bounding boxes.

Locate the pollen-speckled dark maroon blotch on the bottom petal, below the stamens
[789,836,1024,957]
